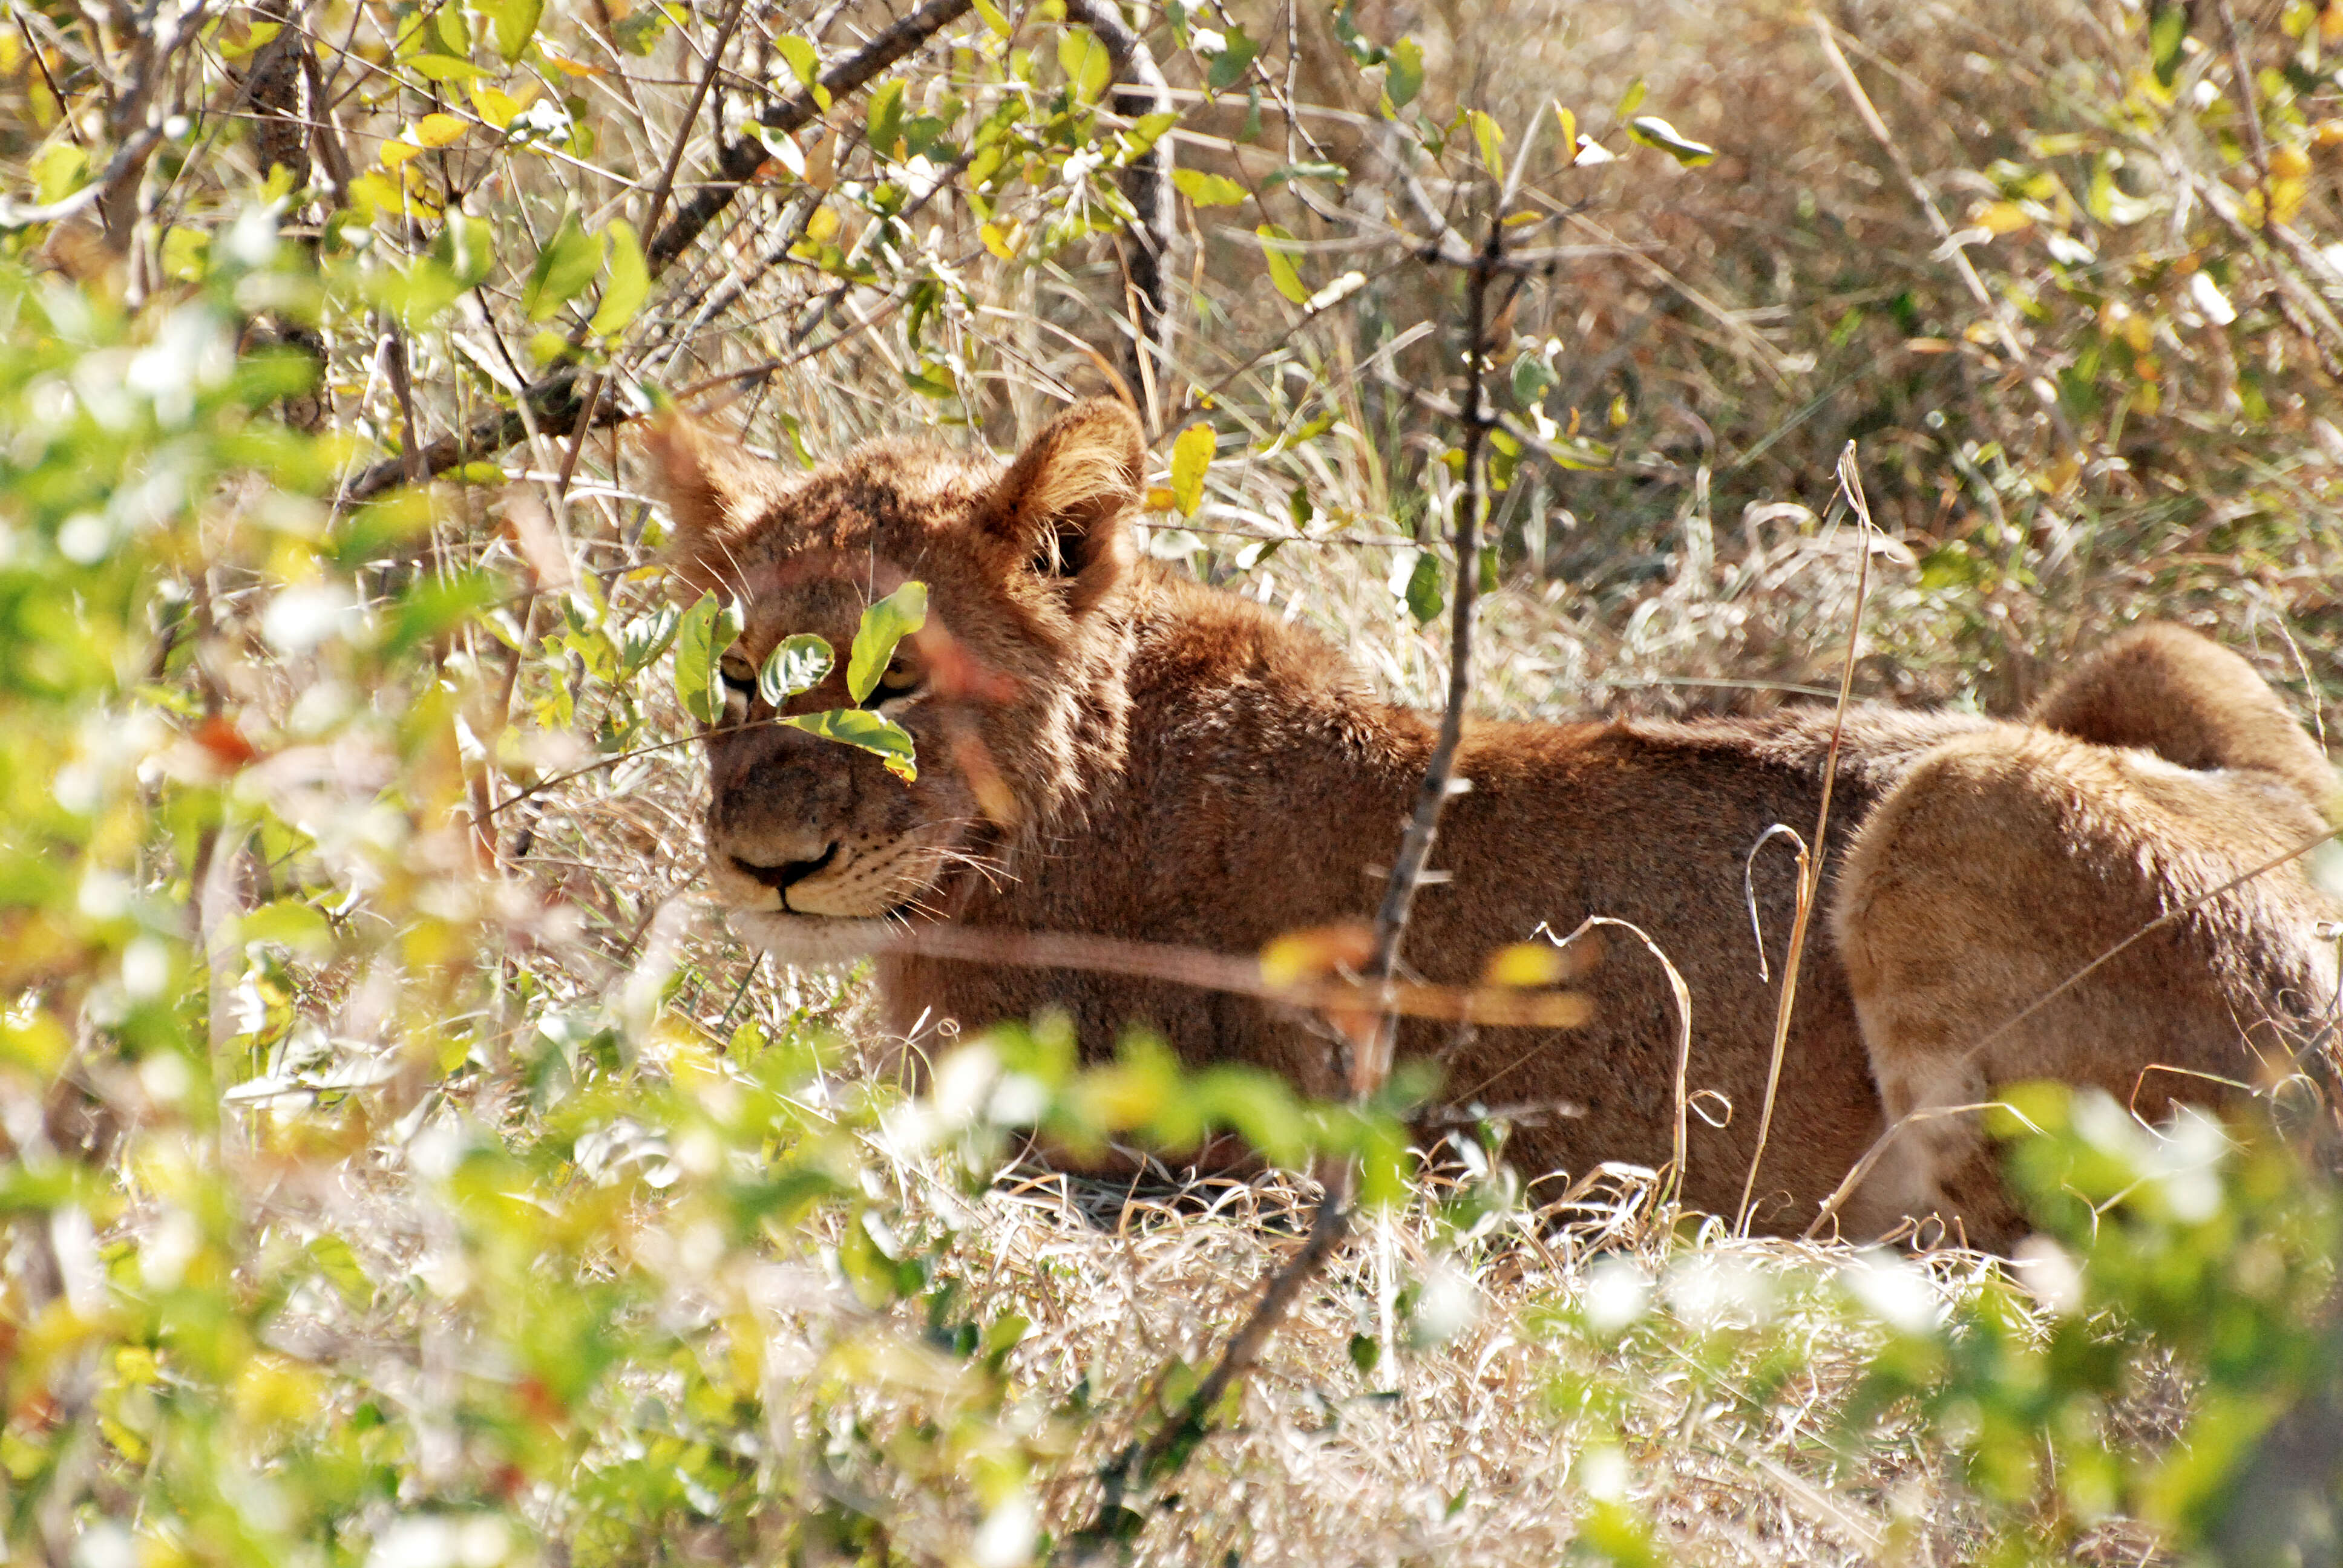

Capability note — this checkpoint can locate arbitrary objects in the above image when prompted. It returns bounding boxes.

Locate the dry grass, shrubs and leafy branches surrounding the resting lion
[0,0,2343,1566]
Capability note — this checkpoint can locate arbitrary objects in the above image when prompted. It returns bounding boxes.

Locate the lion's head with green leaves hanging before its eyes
[654,401,1144,961]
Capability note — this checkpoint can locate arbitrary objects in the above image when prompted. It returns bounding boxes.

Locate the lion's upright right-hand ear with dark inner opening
[984,399,1145,609]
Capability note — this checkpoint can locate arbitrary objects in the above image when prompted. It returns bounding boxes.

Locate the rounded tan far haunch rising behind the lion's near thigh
[2029,626,2336,809]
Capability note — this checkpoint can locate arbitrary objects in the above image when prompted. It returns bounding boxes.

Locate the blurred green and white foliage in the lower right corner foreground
[1551,1083,2343,1566]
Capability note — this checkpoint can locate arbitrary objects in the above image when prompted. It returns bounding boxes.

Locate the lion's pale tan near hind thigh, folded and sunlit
[1837,727,2336,1238]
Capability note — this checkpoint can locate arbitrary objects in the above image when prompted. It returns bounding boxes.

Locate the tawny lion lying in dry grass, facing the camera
[654,401,2338,1240]
